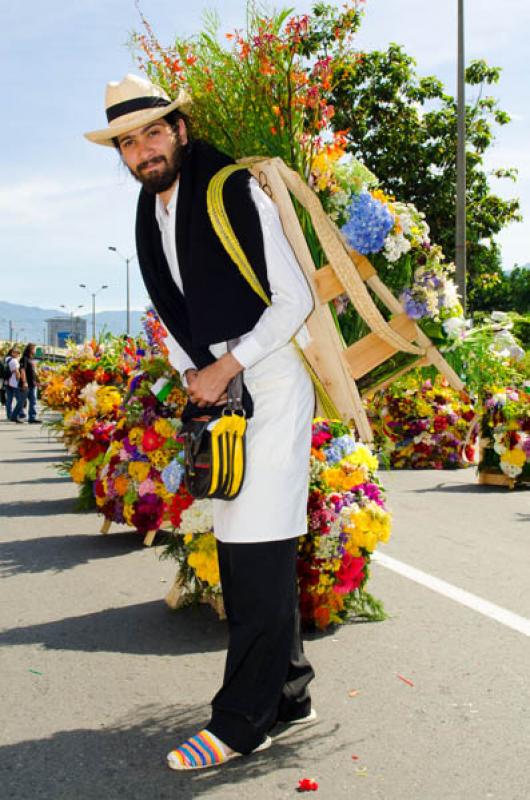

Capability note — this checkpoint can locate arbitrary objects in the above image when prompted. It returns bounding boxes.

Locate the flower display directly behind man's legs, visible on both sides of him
[166,419,391,629]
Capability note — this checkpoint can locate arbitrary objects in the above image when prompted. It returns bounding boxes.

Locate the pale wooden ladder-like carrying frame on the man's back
[243,158,464,443]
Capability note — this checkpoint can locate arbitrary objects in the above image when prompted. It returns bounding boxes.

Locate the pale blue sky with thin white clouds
[0,0,530,324]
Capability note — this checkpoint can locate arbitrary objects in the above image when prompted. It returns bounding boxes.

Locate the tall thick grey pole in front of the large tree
[455,0,467,313]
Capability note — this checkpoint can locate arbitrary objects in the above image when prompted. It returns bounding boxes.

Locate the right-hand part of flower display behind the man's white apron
[298,418,391,629]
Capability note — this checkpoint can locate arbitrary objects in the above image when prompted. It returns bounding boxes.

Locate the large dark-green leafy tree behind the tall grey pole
[331,44,521,310]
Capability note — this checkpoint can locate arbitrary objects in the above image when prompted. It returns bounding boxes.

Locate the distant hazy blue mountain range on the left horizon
[0,301,144,344]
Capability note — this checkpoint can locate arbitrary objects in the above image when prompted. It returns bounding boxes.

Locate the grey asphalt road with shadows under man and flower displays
[0,421,530,800]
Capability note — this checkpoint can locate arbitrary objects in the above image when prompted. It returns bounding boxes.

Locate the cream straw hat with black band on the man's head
[85,75,191,147]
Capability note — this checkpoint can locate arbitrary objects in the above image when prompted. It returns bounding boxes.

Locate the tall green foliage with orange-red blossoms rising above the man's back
[131,0,362,176]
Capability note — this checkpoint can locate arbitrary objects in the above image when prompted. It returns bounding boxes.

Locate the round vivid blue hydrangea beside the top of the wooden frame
[342,191,394,255]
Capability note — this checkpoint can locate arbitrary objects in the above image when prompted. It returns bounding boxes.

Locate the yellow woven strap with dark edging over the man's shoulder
[206,166,340,419]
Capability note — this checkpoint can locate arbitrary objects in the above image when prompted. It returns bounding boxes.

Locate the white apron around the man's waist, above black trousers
[211,343,315,543]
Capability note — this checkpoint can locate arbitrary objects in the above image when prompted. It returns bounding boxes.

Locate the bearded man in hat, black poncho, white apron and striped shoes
[86,75,316,769]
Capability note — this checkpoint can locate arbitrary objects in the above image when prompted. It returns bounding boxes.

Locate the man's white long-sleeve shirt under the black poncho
[155,178,313,376]
